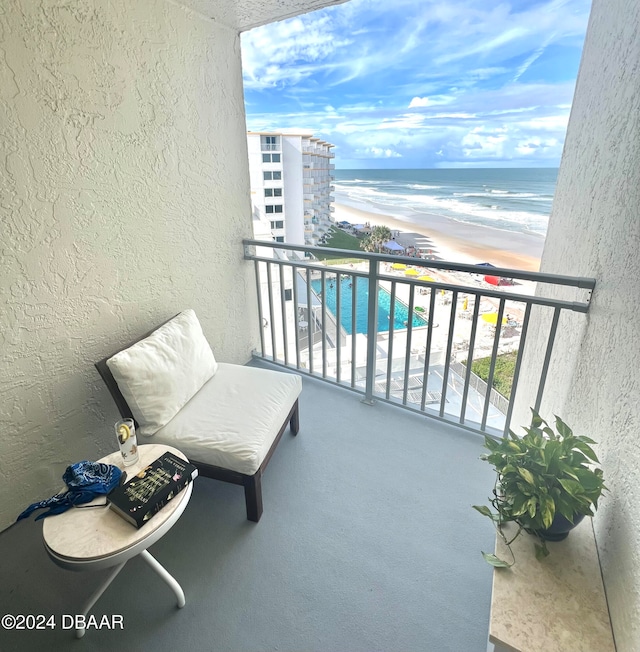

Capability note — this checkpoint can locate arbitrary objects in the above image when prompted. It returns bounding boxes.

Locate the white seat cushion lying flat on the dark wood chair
[148,362,302,475]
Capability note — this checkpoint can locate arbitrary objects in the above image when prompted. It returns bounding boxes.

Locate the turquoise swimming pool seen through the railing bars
[311,276,427,335]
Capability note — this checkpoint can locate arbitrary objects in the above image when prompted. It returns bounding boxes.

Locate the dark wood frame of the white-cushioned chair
[95,322,300,523]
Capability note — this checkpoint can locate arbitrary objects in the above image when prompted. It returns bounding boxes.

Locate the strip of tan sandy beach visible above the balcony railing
[333,203,544,272]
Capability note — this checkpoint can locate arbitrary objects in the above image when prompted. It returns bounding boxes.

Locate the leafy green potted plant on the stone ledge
[473,409,606,568]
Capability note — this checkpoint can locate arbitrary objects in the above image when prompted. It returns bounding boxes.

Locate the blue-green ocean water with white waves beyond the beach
[335,168,558,236]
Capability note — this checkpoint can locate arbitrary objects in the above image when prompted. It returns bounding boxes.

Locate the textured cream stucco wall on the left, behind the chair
[0,0,258,528]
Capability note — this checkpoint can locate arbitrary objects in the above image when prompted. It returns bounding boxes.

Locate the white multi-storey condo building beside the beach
[247,132,335,245]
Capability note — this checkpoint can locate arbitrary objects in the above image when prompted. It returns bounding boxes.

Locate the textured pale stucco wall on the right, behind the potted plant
[516,0,640,652]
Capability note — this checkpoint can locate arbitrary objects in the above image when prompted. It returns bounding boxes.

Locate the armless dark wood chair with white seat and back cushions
[95,310,302,522]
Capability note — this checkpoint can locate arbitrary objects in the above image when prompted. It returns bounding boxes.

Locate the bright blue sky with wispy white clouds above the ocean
[242,0,591,168]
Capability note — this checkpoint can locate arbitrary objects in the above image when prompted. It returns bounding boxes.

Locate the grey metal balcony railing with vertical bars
[243,240,595,435]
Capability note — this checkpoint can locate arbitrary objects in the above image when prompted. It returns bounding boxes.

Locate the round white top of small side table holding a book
[42,444,193,567]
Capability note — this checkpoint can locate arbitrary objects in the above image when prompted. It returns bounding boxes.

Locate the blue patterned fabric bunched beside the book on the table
[16,460,122,521]
